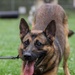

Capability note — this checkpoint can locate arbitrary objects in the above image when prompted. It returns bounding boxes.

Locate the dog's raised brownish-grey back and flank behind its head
[33,4,68,54]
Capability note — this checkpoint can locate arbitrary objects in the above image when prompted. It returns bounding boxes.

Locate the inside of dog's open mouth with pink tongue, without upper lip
[24,56,44,75]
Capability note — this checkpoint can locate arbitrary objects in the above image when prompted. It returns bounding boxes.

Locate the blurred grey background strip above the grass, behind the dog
[0,0,75,24]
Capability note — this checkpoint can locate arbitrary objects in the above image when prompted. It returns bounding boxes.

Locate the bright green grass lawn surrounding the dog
[0,12,75,75]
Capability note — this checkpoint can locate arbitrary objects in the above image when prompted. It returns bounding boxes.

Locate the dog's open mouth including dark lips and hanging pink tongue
[23,51,46,75]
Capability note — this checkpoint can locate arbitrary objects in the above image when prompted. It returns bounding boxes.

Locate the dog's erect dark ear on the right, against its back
[44,20,56,43]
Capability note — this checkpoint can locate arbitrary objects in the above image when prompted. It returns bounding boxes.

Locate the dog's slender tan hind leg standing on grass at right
[63,37,70,75]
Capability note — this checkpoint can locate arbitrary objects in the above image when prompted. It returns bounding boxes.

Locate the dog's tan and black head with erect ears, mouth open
[19,18,56,75]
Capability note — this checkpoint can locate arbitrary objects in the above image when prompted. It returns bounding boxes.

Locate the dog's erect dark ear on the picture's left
[19,18,30,38]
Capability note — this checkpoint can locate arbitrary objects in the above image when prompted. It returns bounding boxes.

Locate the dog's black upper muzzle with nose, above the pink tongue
[22,51,46,63]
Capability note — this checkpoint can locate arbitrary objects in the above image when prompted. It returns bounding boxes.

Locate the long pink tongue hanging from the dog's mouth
[24,62,34,75]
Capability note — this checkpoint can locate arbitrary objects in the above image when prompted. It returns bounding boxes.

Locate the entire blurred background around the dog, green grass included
[0,0,75,75]
